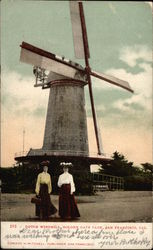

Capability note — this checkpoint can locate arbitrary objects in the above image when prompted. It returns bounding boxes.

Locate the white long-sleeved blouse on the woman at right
[57,173,75,194]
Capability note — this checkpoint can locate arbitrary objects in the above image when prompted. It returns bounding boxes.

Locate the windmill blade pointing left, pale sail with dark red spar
[20,42,85,78]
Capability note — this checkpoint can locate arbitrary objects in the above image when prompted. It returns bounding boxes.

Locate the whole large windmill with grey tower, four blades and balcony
[15,1,133,167]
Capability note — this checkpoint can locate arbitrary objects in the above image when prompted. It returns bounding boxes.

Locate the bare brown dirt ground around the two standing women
[1,191,152,222]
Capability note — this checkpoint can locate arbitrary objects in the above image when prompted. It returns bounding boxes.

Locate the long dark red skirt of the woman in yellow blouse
[36,184,57,219]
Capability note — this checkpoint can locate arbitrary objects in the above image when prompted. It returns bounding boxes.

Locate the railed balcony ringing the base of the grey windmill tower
[15,149,110,158]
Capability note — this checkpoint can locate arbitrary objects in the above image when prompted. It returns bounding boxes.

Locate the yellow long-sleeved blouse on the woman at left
[35,172,52,195]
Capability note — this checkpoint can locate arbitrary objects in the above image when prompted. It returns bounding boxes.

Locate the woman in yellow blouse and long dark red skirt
[35,163,57,219]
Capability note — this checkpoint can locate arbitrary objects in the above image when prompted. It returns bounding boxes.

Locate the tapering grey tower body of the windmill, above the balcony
[42,71,89,156]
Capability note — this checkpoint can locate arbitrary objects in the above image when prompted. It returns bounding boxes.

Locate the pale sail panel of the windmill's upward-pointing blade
[69,1,90,59]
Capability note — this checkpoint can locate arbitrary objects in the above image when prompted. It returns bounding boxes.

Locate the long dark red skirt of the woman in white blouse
[59,184,80,218]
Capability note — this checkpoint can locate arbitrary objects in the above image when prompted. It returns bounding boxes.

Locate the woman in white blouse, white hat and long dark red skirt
[58,163,80,218]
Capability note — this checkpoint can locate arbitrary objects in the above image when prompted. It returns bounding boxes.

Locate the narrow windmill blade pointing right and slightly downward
[90,71,134,93]
